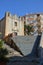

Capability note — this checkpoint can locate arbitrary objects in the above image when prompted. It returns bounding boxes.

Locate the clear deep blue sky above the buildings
[0,0,43,18]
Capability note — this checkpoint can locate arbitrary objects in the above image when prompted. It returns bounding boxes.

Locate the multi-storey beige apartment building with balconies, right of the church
[23,13,43,34]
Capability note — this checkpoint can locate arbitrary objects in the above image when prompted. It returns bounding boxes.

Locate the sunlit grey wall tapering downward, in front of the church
[12,36,37,55]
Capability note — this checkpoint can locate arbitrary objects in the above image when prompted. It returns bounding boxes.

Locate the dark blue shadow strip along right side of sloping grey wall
[31,35,41,57]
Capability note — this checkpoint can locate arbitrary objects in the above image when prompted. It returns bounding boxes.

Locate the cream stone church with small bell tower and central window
[0,12,24,37]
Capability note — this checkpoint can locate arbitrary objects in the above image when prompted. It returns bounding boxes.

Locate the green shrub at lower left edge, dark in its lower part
[0,40,8,61]
